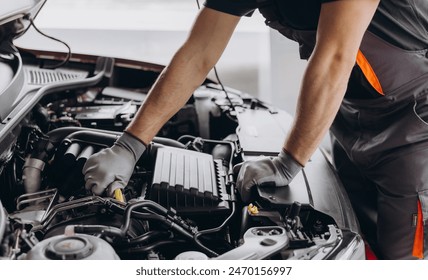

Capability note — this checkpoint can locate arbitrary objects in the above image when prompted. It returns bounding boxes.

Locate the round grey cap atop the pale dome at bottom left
[45,236,94,260]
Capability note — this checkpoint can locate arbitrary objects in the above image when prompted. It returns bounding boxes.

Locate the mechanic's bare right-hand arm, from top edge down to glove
[284,0,379,165]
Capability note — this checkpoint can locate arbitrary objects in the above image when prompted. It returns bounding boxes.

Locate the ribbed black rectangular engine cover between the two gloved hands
[150,147,229,217]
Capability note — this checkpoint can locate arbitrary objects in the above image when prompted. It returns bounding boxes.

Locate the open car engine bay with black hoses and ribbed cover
[0,49,360,260]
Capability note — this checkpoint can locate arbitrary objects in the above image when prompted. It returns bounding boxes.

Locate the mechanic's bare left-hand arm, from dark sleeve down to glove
[126,8,240,144]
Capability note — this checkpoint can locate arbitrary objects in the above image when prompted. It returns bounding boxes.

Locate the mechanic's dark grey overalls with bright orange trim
[257,0,428,259]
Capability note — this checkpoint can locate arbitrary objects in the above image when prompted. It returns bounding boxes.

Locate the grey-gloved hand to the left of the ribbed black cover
[83,132,146,197]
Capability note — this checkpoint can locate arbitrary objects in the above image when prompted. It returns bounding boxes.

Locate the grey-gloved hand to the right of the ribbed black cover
[236,150,303,203]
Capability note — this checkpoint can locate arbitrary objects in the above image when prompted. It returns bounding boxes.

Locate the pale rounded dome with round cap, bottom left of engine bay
[26,234,119,260]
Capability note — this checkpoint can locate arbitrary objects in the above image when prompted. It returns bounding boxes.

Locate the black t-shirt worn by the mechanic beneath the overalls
[205,0,428,50]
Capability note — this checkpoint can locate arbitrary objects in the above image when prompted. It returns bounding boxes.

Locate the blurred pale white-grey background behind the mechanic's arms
[16,0,306,114]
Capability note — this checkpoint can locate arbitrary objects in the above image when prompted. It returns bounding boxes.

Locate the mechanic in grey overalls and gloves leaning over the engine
[83,0,428,259]
